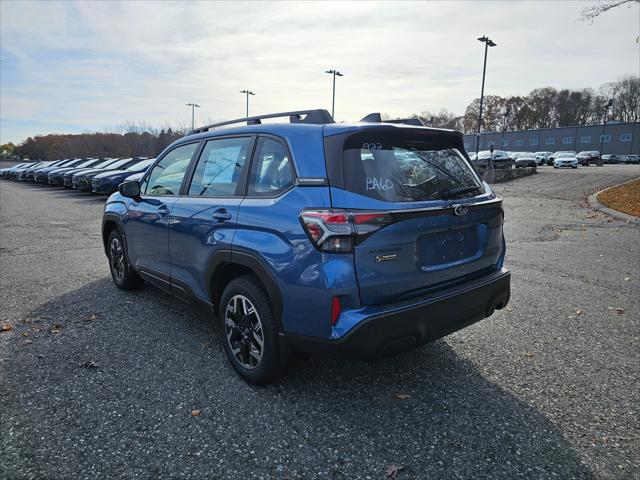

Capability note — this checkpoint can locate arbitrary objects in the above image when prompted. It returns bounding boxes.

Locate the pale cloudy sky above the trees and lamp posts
[0,0,640,143]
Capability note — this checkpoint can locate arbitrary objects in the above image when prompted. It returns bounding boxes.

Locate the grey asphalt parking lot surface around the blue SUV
[0,166,640,479]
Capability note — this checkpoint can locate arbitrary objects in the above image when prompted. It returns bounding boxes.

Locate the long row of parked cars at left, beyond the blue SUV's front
[0,157,155,195]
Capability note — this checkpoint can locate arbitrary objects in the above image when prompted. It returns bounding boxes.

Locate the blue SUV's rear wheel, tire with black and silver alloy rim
[218,275,284,385]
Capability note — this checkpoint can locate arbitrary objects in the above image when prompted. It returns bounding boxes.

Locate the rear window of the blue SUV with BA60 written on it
[342,135,481,202]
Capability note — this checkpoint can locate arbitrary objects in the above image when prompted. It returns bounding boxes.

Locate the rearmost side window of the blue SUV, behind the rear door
[249,137,293,196]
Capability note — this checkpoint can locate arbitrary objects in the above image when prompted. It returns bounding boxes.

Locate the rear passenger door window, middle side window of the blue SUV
[189,137,251,197]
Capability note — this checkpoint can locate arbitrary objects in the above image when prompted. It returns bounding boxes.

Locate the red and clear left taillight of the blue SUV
[300,210,393,253]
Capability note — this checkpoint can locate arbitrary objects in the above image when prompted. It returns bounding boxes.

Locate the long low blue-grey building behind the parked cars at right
[464,122,640,155]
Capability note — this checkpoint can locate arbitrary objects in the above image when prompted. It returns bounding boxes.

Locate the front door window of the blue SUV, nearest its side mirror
[140,143,198,196]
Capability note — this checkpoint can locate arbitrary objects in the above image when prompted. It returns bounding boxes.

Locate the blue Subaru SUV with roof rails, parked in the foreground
[102,110,510,384]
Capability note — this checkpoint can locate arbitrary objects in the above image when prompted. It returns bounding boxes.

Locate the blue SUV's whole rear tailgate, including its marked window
[325,125,503,305]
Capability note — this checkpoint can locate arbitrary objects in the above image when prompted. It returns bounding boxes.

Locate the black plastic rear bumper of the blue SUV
[285,268,511,358]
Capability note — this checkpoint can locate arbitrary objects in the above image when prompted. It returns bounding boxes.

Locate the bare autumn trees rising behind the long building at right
[413,76,640,134]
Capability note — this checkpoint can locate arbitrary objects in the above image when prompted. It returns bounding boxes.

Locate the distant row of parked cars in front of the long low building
[470,150,640,168]
